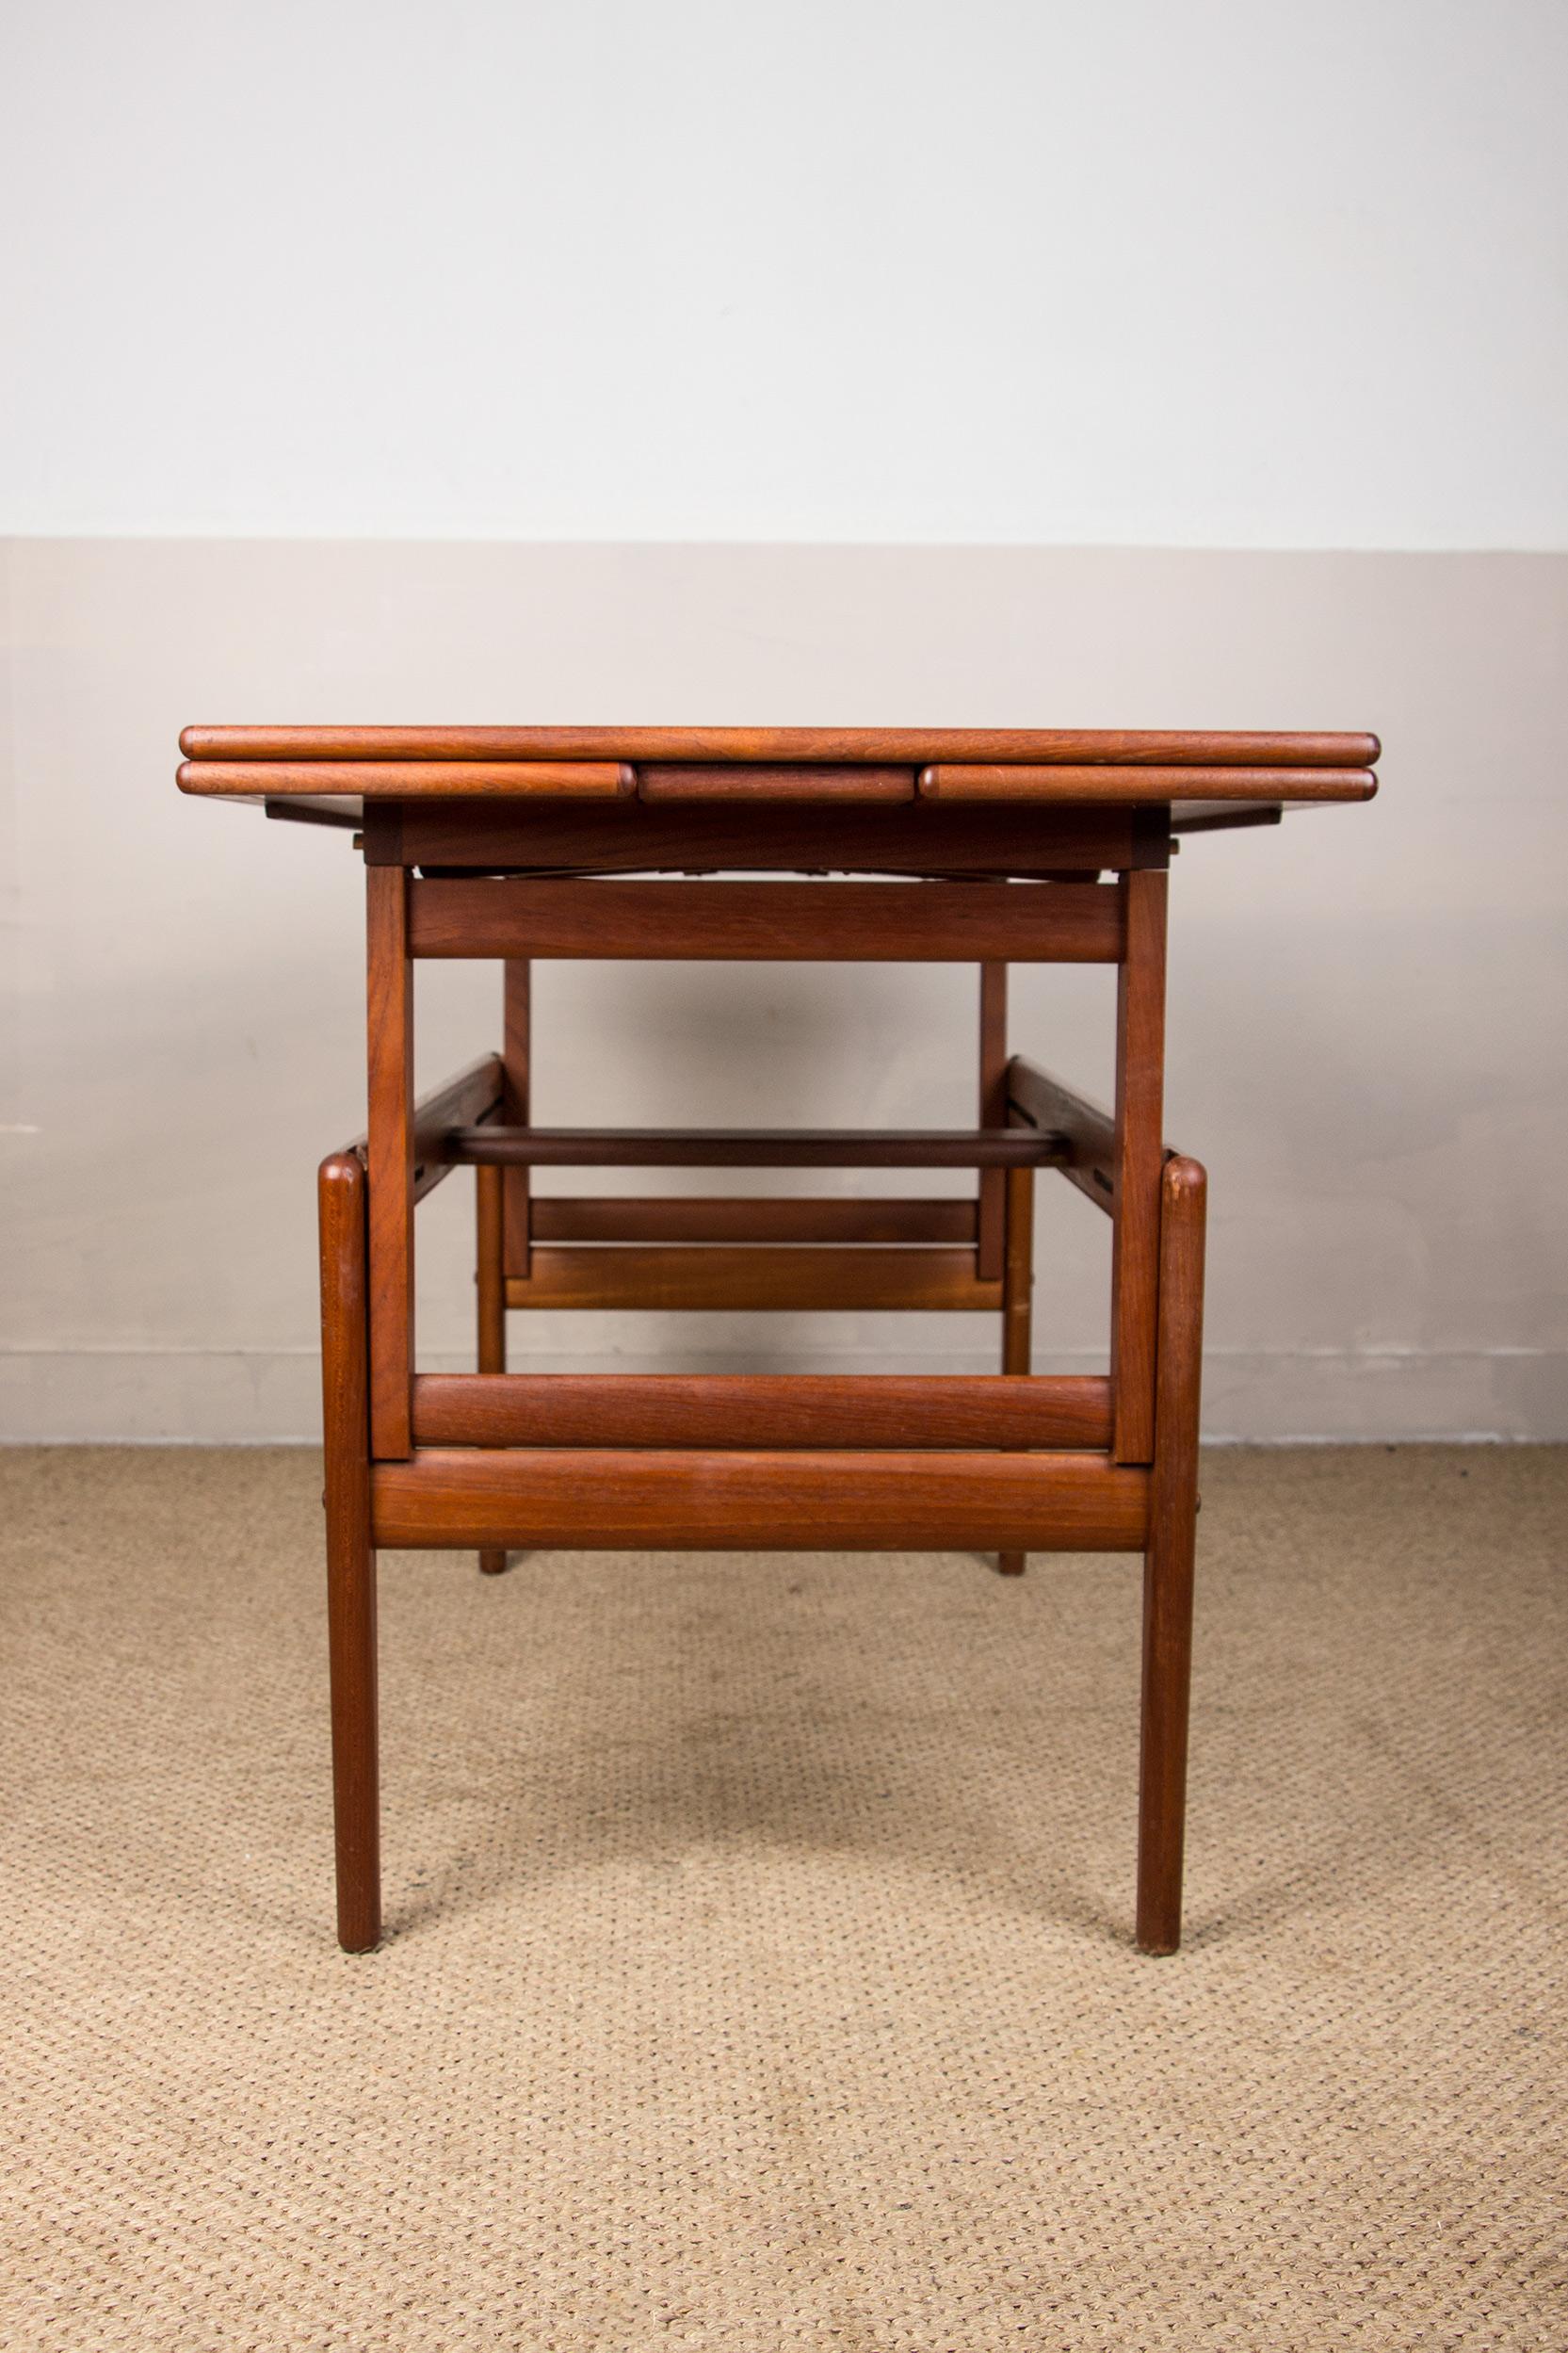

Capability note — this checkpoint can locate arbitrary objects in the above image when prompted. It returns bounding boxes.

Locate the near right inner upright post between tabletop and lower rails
[1109,873,1166,1464]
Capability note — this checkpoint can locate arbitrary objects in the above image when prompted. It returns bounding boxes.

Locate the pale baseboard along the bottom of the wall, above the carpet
[0,1346,1568,1445]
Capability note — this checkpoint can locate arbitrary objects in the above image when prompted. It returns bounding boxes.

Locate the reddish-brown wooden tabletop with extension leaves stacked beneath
[179,727,1378,821]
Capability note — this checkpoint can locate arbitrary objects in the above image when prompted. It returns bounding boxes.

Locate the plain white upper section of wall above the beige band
[0,0,1568,548]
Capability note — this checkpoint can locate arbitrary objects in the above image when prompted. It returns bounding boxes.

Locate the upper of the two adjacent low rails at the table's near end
[413,1371,1109,1450]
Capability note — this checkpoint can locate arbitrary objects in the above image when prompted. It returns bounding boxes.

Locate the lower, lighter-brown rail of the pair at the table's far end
[506,1242,1001,1313]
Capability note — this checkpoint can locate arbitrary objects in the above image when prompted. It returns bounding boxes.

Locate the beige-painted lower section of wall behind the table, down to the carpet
[0,542,1568,1437]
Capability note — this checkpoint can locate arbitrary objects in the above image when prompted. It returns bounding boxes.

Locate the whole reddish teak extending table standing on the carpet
[179,727,1378,1953]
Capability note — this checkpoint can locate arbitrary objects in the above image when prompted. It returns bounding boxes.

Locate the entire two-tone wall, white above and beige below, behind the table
[0,0,1568,1437]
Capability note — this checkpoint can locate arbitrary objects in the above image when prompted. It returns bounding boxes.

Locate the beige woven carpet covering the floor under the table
[0,1447,1568,2353]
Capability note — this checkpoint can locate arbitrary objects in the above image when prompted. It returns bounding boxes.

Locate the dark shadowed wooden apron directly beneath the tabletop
[382,800,1142,875]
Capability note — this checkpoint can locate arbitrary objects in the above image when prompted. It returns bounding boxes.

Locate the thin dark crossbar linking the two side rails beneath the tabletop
[440,1120,1070,1170]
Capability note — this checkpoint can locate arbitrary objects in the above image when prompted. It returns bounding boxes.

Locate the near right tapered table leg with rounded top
[1138,1160,1208,1953]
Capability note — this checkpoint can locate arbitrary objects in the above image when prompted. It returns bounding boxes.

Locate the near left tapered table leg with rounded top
[319,1153,380,1953]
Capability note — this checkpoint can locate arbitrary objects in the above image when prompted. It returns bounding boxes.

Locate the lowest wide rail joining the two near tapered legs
[371,1447,1150,1553]
